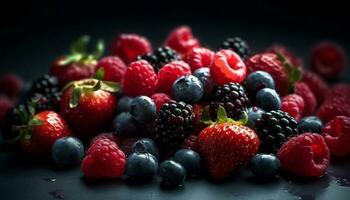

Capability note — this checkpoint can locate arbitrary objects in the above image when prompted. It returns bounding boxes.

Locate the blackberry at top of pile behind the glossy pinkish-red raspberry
[220,37,250,59]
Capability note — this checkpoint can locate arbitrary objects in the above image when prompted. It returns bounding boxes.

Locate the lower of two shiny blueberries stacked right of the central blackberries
[256,88,281,111]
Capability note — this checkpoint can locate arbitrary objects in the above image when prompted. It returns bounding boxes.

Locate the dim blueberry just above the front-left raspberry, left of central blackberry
[113,112,138,136]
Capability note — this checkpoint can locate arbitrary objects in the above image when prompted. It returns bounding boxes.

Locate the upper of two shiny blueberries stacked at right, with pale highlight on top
[245,71,275,97]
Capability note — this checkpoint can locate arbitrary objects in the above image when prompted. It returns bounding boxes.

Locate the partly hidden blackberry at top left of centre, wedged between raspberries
[138,47,181,72]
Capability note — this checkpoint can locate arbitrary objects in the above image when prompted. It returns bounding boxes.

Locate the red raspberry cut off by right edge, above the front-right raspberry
[322,116,350,157]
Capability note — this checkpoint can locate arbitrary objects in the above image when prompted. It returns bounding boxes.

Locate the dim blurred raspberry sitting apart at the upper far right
[310,42,347,79]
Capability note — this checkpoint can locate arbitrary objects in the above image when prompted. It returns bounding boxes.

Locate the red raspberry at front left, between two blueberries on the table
[81,139,126,178]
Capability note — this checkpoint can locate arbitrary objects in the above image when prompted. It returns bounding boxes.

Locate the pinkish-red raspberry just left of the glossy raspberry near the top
[184,47,214,72]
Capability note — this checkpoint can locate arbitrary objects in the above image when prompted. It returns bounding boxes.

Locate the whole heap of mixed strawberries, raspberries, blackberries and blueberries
[0,26,350,186]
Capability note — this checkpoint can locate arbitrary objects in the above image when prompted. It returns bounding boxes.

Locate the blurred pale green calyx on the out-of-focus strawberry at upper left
[58,35,105,66]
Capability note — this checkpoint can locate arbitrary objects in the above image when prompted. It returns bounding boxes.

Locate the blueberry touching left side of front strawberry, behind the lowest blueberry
[174,149,201,177]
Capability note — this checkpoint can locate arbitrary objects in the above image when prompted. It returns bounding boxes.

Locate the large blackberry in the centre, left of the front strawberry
[152,100,195,150]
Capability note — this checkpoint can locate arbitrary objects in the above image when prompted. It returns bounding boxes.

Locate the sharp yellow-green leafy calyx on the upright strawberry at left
[63,78,120,108]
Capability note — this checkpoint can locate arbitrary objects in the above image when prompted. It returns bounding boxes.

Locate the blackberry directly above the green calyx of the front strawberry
[209,83,249,120]
